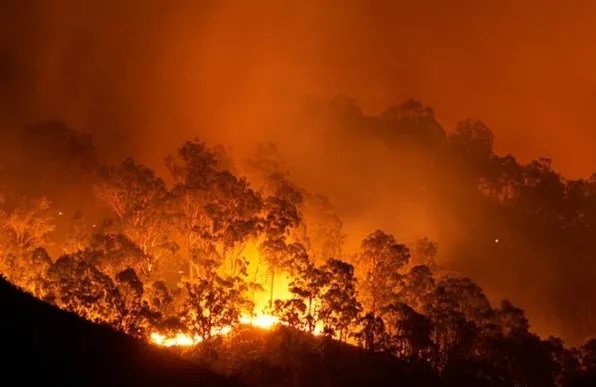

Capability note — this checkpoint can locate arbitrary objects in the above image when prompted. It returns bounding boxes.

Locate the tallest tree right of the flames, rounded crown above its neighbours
[359,230,410,314]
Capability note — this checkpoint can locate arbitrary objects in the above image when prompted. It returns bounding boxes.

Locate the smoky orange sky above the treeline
[0,0,596,176]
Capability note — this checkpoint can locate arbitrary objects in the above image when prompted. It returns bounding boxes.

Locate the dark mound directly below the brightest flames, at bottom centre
[181,327,442,387]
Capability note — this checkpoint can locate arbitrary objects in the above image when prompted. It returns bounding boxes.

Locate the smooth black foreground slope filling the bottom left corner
[0,278,244,387]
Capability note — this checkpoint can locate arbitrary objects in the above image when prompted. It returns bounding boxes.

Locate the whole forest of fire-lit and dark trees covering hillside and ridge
[0,100,596,387]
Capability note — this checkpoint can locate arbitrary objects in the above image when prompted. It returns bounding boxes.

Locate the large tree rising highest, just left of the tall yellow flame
[167,141,261,281]
